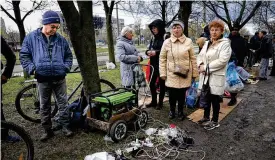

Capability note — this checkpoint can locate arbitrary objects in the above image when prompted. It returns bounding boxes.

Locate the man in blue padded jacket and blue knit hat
[20,11,73,141]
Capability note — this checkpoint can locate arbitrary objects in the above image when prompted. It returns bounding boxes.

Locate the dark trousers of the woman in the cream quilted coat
[168,88,188,113]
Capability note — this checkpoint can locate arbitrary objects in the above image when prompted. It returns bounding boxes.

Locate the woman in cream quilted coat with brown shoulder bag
[159,21,198,120]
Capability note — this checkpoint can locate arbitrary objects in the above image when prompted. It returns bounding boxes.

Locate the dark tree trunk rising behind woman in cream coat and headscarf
[179,1,193,37]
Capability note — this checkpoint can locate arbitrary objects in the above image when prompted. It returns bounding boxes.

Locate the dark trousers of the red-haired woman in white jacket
[204,94,220,122]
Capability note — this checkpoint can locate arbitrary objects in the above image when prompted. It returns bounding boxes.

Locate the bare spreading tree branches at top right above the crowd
[203,0,262,31]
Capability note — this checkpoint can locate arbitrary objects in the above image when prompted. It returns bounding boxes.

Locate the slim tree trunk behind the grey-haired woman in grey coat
[102,0,118,64]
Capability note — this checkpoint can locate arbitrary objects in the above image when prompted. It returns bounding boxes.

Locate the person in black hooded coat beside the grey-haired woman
[145,19,165,109]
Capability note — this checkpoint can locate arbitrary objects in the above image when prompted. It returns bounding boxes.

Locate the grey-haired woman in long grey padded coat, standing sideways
[116,26,143,88]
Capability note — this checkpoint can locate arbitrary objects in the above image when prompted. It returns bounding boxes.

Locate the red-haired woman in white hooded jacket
[197,20,232,130]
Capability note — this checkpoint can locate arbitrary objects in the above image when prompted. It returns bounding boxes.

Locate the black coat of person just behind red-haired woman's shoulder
[229,34,248,62]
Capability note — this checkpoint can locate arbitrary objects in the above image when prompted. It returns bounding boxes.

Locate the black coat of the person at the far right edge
[258,36,273,58]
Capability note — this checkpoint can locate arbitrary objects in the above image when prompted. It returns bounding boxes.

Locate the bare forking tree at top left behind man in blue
[1,0,48,44]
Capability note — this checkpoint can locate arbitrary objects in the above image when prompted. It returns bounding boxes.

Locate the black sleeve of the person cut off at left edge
[1,36,16,78]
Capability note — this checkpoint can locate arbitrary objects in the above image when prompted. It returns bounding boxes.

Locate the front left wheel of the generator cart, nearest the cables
[110,120,128,142]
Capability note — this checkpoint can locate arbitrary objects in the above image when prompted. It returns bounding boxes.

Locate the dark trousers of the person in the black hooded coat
[150,71,165,104]
